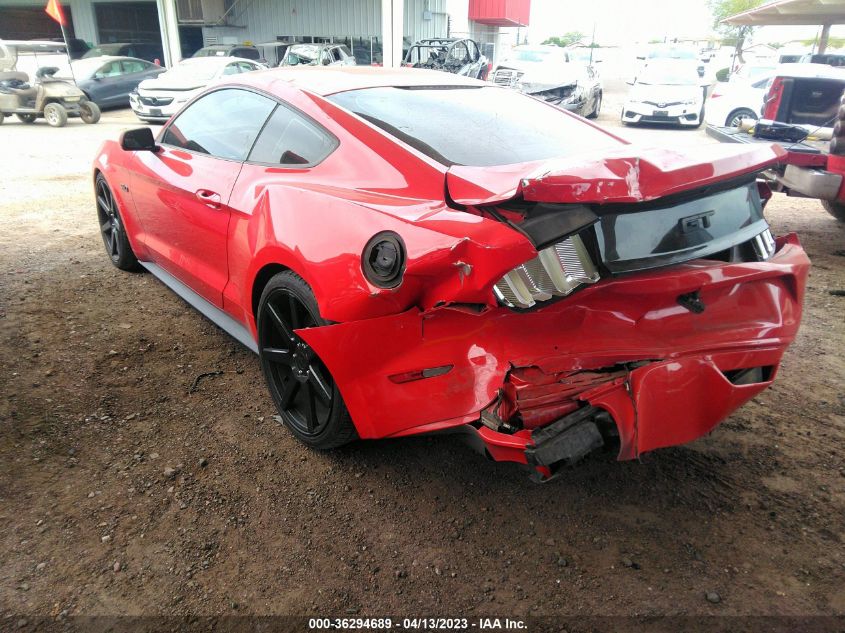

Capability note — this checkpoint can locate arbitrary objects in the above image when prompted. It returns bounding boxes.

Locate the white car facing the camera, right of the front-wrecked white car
[622,60,705,127]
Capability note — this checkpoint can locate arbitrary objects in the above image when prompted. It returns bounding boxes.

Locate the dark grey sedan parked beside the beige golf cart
[73,57,165,108]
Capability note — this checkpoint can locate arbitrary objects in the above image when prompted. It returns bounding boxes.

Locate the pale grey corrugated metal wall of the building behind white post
[203,0,448,43]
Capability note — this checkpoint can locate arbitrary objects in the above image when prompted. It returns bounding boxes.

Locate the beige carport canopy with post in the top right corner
[722,0,845,53]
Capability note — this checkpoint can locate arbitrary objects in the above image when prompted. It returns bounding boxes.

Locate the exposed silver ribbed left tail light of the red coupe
[493,235,600,309]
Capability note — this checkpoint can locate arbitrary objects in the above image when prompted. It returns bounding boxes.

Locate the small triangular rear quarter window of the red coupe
[249,106,337,165]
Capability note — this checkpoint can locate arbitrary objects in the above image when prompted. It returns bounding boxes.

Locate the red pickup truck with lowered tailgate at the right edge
[707,63,845,222]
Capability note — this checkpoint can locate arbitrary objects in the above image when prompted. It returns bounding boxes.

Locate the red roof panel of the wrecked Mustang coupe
[231,66,484,96]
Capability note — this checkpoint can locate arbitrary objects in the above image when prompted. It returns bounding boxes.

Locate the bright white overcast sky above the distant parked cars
[528,0,845,45]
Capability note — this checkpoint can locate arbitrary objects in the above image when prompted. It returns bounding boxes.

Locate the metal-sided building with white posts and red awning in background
[0,0,530,66]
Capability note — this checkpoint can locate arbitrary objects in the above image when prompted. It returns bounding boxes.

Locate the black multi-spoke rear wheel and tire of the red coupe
[256,270,358,450]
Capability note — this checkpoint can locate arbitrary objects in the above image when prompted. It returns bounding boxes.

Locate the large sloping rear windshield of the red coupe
[328,86,619,167]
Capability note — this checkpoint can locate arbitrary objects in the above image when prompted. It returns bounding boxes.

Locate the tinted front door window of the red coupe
[162,88,276,161]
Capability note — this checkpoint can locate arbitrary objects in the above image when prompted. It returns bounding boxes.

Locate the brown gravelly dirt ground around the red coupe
[0,99,845,630]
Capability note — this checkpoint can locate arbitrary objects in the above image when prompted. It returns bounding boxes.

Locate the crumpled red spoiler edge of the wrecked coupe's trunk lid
[446,144,786,206]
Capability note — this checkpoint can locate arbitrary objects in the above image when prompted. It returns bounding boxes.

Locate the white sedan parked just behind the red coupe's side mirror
[129,57,265,123]
